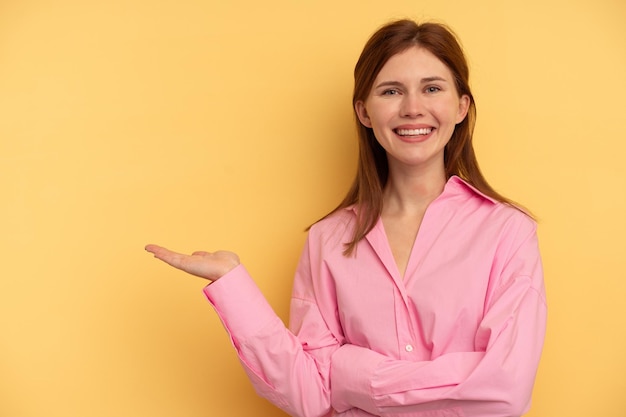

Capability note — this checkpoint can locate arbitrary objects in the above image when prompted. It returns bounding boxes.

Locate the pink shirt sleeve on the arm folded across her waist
[331,218,547,417]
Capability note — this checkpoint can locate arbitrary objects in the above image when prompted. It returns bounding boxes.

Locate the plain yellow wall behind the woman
[0,0,626,417]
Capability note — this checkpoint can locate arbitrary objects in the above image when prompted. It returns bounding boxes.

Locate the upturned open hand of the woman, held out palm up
[146,245,240,281]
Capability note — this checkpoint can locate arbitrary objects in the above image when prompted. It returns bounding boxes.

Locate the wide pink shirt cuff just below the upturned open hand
[203,265,276,344]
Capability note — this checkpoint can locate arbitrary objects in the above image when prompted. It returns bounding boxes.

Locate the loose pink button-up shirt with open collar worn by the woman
[204,177,546,417]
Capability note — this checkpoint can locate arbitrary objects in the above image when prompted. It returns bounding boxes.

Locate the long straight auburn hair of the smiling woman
[316,19,526,256]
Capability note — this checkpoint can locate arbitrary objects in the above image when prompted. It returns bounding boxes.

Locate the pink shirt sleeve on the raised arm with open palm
[204,232,339,417]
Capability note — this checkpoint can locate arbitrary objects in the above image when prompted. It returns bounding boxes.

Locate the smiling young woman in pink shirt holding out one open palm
[146,20,546,417]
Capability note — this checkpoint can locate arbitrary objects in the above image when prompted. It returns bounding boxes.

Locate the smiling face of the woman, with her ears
[355,46,470,169]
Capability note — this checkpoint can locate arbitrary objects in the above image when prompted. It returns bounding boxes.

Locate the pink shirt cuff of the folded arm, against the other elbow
[330,345,386,415]
